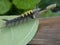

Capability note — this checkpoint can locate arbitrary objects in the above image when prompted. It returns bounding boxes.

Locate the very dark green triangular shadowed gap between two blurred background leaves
[5,5,24,15]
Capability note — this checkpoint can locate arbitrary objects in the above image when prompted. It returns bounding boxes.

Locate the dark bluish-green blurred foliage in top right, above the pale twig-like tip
[38,0,60,8]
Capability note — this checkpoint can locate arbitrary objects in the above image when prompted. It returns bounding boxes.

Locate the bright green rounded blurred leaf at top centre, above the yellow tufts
[13,0,40,9]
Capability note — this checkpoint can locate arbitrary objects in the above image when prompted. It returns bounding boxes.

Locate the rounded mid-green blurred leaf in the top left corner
[0,0,11,14]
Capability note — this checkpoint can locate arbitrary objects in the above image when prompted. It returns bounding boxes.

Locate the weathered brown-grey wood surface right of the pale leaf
[29,17,60,45]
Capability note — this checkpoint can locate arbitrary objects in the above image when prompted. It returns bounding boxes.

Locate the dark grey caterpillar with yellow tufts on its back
[3,8,40,26]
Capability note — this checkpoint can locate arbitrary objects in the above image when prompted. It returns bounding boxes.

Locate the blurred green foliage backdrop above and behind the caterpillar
[0,0,60,17]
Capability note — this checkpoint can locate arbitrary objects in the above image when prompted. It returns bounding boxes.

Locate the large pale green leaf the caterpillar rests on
[0,16,39,45]
